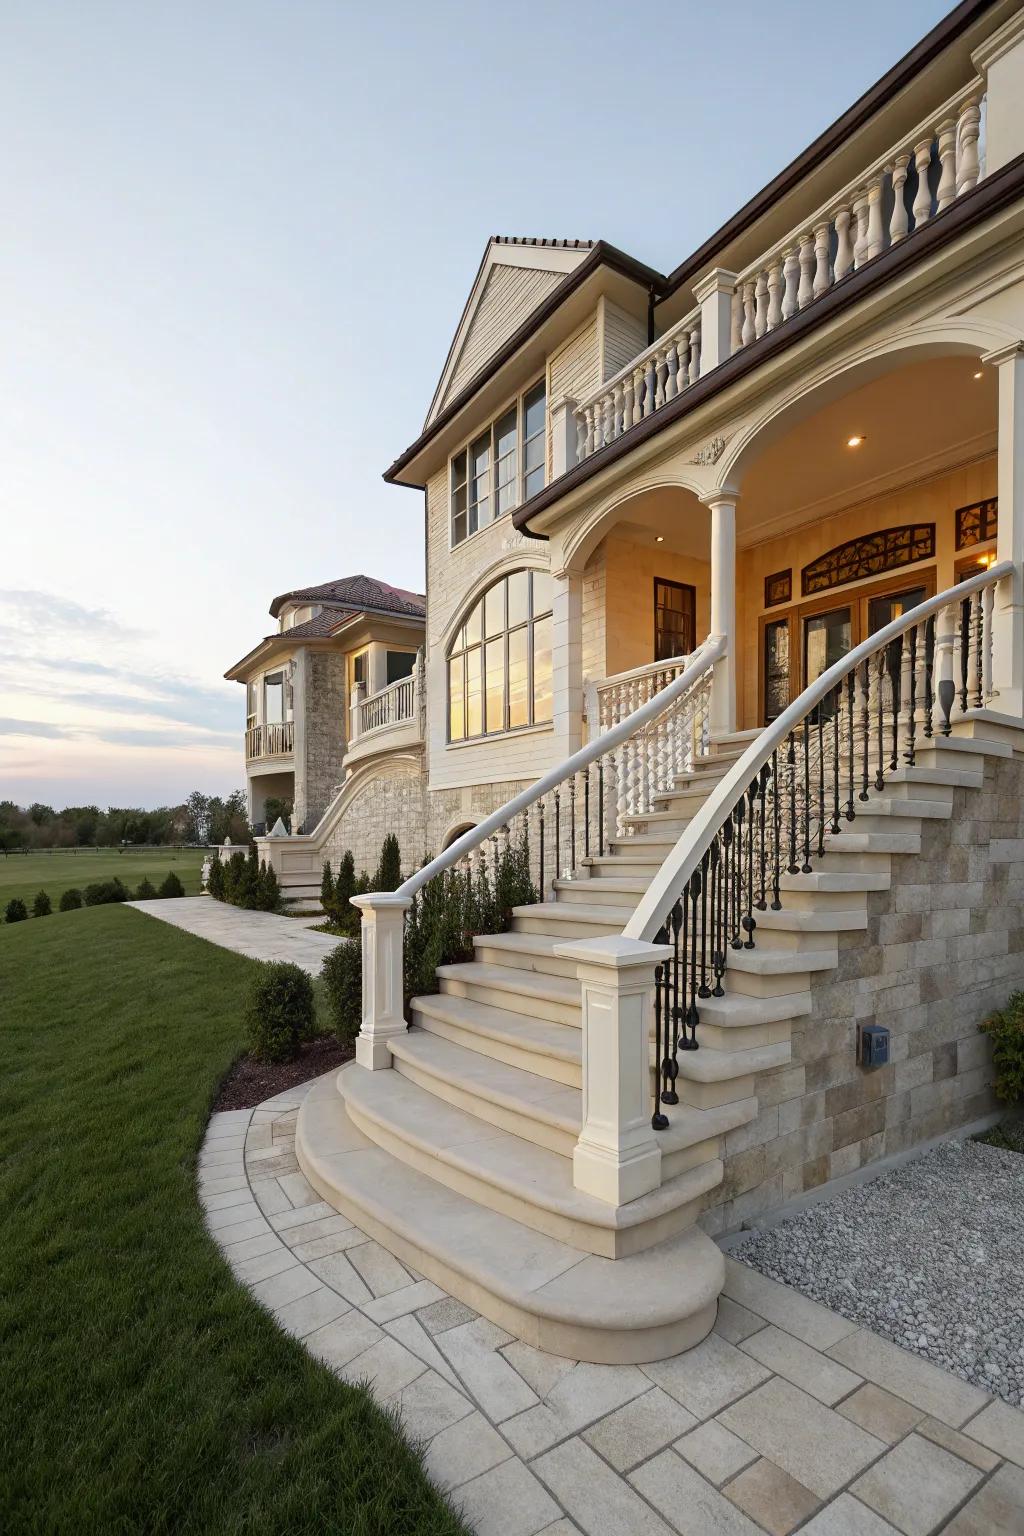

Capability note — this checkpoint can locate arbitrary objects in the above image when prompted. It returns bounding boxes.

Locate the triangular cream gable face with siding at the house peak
[424,235,594,427]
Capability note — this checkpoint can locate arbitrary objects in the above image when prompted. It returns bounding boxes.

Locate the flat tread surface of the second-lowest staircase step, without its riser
[339,1052,721,1232]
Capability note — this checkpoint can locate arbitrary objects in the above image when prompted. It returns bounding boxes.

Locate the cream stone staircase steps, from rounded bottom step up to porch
[296,571,1019,1362]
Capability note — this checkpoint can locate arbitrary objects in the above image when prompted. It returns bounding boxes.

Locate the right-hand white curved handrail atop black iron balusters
[623,561,1013,943]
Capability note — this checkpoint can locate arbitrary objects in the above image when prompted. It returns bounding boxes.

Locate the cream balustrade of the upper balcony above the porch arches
[573,77,986,462]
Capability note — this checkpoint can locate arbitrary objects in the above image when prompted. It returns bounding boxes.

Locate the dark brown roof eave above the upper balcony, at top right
[659,0,995,303]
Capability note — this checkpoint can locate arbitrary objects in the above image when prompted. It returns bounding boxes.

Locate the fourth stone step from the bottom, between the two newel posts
[411,992,583,1087]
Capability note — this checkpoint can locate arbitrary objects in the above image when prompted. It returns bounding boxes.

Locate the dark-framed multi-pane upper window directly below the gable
[450,379,545,545]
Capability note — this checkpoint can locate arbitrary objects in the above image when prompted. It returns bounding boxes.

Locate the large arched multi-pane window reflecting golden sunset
[448,570,551,742]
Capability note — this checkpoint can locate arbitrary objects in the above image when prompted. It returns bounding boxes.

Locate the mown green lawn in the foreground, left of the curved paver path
[0,906,462,1536]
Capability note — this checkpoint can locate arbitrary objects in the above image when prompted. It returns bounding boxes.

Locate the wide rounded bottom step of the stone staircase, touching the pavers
[295,1068,725,1366]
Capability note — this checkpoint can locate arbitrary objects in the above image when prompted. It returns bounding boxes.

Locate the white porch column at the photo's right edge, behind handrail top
[981,341,1024,716]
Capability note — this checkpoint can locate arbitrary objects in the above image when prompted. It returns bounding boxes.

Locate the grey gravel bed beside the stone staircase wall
[731,1141,1024,1407]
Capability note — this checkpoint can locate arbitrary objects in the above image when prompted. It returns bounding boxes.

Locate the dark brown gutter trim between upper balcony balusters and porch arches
[513,154,1024,538]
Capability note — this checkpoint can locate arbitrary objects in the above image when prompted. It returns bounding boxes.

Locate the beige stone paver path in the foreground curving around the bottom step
[199,1081,1024,1536]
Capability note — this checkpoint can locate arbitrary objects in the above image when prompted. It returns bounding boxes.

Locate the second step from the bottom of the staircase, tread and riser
[339,1066,724,1258]
